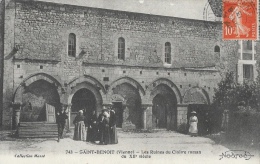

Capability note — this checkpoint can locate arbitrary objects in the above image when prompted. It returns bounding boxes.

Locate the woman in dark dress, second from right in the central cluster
[100,112,110,145]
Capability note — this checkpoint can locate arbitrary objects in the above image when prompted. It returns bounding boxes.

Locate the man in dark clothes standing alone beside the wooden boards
[57,104,68,142]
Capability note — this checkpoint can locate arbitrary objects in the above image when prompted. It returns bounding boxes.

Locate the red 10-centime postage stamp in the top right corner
[222,0,258,40]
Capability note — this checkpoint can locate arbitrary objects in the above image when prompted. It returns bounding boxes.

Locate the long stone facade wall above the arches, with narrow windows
[3,1,242,128]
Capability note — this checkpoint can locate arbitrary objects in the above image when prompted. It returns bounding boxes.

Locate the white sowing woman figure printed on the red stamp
[229,0,252,37]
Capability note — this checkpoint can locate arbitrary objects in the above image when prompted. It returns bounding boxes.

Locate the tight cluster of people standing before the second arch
[73,108,118,145]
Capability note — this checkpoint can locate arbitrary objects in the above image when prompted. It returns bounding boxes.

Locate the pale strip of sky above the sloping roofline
[39,0,211,20]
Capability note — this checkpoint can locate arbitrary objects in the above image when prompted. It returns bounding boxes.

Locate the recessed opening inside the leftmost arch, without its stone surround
[20,79,60,122]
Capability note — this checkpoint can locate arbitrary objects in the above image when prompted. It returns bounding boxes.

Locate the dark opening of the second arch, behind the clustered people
[71,88,97,125]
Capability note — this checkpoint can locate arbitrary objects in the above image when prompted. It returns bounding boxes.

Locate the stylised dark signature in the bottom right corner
[219,150,254,160]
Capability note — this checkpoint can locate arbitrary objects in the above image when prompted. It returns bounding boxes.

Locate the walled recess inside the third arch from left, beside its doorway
[113,83,142,129]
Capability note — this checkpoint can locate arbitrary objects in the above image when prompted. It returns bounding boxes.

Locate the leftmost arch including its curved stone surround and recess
[13,73,63,122]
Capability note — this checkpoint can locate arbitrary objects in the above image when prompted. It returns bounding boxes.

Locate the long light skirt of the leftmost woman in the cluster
[73,121,87,141]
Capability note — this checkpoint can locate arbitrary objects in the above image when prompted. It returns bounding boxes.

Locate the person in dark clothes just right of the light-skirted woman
[87,110,98,142]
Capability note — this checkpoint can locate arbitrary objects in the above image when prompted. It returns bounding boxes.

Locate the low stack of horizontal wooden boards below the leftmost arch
[17,122,58,138]
